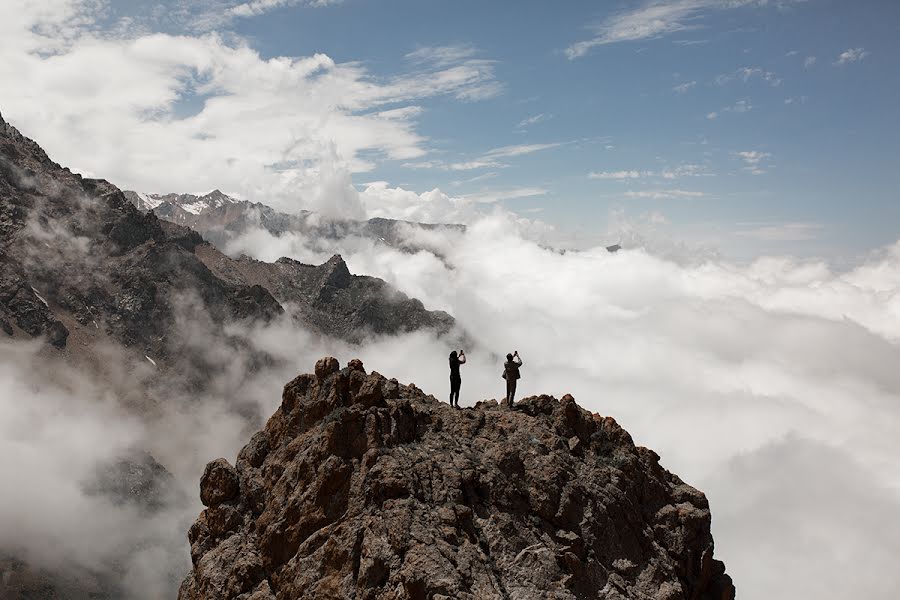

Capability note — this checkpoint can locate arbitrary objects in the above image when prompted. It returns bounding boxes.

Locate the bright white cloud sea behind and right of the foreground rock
[223,211,900,600]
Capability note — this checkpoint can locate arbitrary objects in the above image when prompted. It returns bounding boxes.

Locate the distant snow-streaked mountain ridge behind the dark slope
[125,190,465,252]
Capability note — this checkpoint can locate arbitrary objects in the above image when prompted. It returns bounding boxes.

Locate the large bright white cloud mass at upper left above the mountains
[0,0,497,216]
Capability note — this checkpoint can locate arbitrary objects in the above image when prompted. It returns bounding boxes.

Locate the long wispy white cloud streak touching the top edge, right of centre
[566,0,792,60]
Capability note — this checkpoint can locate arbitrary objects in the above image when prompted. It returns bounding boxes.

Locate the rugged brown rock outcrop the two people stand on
[179,358,734,600]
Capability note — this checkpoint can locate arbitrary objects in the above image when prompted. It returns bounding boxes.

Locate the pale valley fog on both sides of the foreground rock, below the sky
[0,211,900,600]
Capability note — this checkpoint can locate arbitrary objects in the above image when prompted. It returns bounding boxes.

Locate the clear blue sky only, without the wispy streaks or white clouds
[234,0,900,253]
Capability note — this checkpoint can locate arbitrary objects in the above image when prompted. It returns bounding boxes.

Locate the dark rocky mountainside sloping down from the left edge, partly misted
[0,112,453,362]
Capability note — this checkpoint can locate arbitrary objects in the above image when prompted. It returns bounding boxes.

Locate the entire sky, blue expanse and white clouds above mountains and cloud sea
[0,0,900,263]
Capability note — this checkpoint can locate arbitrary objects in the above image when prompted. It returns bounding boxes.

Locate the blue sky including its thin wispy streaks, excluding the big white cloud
[0,0,900,259]
